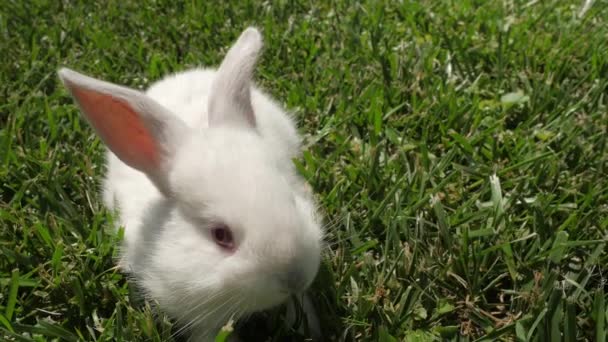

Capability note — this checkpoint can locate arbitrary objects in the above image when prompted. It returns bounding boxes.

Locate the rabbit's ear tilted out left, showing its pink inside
[59,68,188,195]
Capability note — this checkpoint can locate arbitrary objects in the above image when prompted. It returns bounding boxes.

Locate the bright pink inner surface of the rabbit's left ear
[72,88,160,172]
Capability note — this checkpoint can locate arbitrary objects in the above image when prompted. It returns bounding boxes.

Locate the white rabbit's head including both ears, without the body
[59,28,322,332]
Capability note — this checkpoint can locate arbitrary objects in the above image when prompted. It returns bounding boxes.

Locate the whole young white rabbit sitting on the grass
[59,28,322,341]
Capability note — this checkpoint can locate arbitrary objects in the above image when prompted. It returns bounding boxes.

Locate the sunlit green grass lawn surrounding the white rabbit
[0,0,608,341]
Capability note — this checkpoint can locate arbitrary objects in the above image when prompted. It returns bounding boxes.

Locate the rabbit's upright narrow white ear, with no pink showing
[209,27,262,128]
